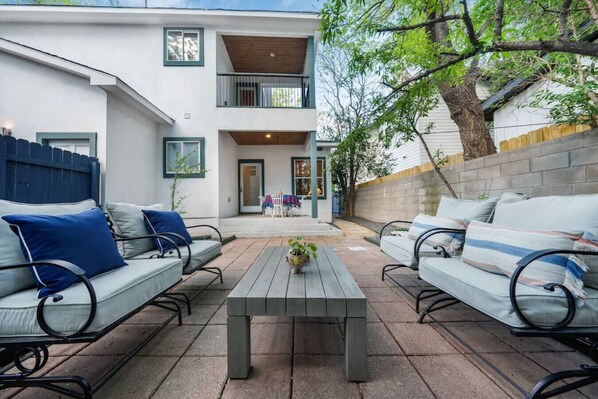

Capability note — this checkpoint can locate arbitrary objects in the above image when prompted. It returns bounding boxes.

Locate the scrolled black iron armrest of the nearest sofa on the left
[0,259,97,339]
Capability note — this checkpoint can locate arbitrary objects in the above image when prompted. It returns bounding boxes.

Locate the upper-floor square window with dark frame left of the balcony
[164,28,204,66]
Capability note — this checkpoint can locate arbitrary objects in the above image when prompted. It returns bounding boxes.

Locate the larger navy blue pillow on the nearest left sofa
[2,208,126,298]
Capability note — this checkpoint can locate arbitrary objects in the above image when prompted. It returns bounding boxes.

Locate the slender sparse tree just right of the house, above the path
[318,46,393,216]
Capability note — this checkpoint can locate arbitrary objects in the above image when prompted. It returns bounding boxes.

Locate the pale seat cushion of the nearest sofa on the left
[0,258,182,337]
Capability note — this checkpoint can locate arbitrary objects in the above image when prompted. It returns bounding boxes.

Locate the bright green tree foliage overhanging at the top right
[321,0,596,155]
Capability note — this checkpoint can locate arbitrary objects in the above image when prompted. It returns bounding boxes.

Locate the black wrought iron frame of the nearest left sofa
[0,235,182,399]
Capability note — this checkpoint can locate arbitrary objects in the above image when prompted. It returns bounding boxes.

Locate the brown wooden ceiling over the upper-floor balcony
[222,35,307,75]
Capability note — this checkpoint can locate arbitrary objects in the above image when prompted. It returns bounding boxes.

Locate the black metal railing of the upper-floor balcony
[217,73,310,108]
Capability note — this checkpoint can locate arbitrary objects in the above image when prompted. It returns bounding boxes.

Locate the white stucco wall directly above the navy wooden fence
[0,53,107,199]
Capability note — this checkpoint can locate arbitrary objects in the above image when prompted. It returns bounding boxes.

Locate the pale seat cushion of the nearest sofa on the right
[419,258,598,327]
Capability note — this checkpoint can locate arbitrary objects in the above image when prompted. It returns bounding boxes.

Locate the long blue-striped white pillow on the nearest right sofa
[461,221,588,305]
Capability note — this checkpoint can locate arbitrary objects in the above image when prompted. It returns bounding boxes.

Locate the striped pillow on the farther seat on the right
[407,214,469,255]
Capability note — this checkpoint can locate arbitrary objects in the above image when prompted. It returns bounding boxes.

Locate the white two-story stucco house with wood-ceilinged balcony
[0,6,332,228]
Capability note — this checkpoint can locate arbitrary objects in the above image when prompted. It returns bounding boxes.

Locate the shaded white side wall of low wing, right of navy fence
[106,95,159,204]
